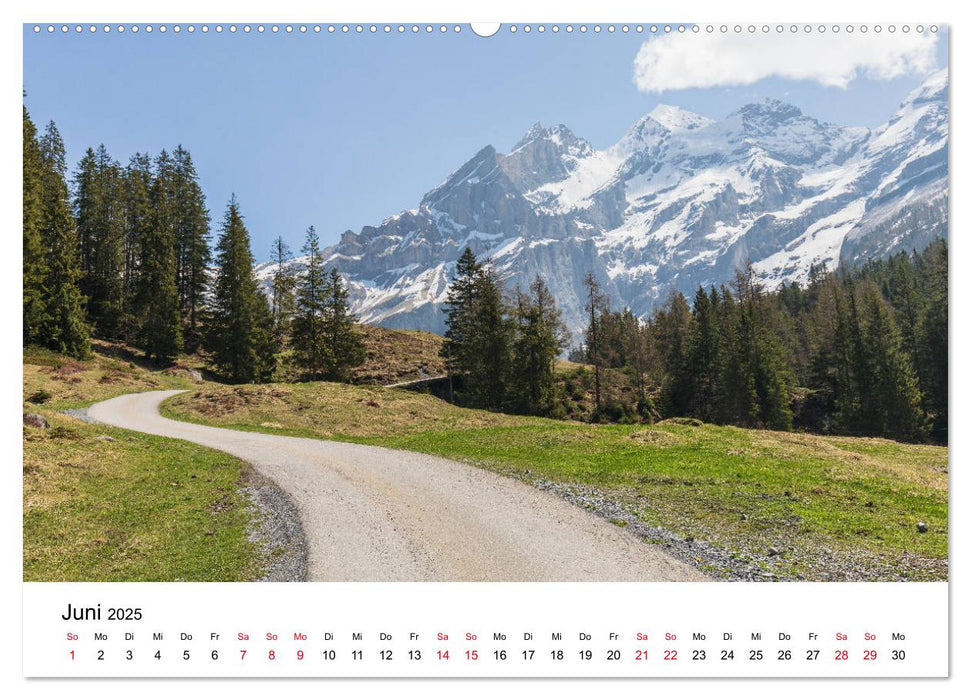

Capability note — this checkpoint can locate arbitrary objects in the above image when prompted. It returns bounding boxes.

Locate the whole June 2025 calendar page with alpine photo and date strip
[21,7,950,688]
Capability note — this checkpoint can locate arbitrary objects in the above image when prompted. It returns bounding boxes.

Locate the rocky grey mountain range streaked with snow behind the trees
[258,70,948,340]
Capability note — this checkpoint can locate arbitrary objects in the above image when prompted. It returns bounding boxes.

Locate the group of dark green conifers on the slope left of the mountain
[23,107,364,382]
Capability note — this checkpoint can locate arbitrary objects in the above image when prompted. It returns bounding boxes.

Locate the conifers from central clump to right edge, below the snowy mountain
[442,240,947,442]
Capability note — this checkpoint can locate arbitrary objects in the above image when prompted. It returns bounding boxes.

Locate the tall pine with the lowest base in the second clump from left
[137,150,182,363]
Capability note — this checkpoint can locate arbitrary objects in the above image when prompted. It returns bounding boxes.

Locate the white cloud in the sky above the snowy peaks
[634,31,937,92]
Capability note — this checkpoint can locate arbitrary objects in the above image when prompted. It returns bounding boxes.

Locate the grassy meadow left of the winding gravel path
[23,343,264,581]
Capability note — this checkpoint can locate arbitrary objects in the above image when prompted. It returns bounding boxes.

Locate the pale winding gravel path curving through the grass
[87,391,705,581]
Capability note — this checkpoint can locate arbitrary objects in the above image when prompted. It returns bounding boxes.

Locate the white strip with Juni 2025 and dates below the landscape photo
[24,583,948,677]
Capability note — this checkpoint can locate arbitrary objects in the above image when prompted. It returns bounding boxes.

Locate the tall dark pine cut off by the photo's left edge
[23,106,47,345]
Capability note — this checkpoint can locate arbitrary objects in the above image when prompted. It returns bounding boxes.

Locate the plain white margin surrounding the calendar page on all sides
[0,0,971,698]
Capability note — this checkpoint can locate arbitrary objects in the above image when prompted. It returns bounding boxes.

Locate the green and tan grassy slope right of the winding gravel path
[165,383,947,580]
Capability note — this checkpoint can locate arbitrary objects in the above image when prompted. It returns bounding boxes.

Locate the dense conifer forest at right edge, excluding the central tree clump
[579,240,948,442]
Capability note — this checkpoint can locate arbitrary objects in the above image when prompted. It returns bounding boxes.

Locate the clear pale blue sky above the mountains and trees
[24,27,947,260]
